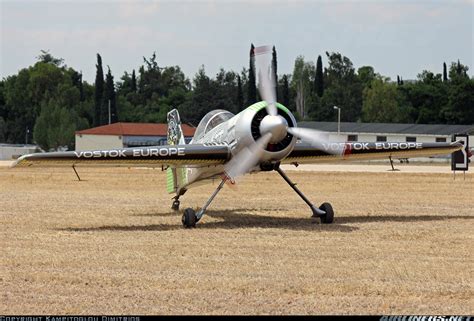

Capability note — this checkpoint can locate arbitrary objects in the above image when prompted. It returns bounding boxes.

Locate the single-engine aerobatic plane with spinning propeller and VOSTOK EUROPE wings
[12,46,463,228]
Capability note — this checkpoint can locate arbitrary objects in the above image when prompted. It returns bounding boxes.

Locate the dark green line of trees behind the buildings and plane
[0,45,474,150]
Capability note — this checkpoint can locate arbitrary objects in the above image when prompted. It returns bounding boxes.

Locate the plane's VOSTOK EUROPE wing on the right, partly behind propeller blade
[282,142,463,164]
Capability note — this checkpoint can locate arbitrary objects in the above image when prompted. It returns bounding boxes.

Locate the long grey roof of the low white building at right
[298,121,474,135]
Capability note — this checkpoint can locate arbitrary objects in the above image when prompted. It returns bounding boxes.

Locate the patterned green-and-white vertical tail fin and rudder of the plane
[166,109,187,194]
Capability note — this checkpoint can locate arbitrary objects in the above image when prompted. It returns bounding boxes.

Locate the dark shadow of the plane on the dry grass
[61,209,358,232]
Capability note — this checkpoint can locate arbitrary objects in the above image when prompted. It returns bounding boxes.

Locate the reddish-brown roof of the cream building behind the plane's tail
[76,123,196,137]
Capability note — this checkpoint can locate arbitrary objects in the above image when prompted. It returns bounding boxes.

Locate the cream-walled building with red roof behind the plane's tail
[76,123,195,150]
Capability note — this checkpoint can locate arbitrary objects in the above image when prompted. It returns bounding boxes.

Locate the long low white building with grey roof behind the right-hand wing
[298,121,474,144]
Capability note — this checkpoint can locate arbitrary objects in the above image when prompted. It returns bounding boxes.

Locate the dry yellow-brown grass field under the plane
[0,167,474,315]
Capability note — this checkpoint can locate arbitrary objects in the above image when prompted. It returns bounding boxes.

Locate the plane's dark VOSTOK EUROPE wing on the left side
[12,144,231,167]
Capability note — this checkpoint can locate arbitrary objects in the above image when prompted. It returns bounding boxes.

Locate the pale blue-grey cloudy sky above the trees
[0,0,474,83]
